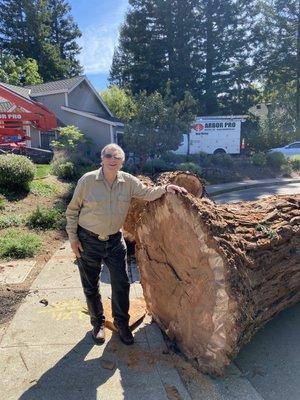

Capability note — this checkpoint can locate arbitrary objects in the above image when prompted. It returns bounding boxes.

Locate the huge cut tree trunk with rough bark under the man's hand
[136,194,300,375]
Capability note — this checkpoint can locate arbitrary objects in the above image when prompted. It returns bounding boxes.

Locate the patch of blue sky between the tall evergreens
[69,0,128,89]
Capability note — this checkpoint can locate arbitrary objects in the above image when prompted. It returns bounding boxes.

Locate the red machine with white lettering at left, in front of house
[0,83,57,150]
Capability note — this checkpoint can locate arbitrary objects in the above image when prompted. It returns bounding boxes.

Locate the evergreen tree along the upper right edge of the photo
[255,0,300,140]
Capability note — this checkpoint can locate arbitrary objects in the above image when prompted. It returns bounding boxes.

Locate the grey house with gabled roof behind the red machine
[0,75,124,153]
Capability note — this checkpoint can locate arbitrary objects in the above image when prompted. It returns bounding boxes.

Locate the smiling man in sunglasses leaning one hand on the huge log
[66,144,187,345]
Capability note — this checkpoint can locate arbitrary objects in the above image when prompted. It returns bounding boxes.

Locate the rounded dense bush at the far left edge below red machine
[0,154,35,190]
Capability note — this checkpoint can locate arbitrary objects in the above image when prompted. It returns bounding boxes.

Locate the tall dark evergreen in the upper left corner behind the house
[0,0,80,81]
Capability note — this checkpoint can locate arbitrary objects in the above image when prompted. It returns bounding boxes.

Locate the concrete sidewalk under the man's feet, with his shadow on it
[0,242,262,400]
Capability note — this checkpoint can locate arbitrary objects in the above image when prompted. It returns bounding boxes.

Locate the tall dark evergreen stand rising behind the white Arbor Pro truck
[110,0,257,114]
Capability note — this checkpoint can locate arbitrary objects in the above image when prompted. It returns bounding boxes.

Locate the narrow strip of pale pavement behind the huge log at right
[206,177,300,196]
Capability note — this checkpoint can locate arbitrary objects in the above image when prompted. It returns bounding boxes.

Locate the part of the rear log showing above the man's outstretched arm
[156,171,205,197]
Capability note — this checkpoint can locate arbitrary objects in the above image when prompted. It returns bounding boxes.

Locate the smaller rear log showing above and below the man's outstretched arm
[123,171,205,243]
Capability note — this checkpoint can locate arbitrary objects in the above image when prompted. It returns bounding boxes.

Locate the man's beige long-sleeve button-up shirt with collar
[66,168,165,242]
